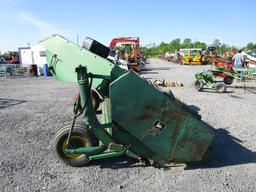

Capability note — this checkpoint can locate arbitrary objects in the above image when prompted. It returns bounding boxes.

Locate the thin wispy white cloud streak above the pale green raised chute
[16,11,74,36]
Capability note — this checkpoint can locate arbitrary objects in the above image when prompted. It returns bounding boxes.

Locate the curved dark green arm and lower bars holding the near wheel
[66,65,127,160]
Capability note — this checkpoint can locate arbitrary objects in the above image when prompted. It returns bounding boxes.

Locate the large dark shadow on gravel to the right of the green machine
[185,129,256,170]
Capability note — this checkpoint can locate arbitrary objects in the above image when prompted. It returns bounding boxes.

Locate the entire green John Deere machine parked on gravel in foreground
[41,35,214,166]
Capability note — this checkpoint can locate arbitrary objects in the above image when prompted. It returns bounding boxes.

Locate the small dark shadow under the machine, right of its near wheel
[86,155,147,169]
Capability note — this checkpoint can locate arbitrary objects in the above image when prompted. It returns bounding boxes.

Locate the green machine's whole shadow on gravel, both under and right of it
[87,129,256,170]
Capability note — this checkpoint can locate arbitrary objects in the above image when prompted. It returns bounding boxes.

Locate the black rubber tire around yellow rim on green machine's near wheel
[52,123,99,167]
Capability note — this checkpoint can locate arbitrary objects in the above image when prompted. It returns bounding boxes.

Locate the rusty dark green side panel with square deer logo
[110,72,214,164]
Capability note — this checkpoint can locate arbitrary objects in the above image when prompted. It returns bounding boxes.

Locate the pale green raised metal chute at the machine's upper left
[40,34,127,97]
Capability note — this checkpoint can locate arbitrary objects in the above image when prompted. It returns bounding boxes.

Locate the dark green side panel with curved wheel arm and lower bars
[67,66,214,165]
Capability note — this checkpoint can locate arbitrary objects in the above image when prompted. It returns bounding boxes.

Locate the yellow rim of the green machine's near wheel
[62,135,90,159]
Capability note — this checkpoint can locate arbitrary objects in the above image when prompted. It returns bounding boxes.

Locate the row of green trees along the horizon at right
[141,38,256,57]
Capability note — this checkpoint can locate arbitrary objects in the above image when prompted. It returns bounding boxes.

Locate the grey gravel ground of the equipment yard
[0,59,256,192]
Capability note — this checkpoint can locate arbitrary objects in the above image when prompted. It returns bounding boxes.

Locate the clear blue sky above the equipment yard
[0,0,256,51]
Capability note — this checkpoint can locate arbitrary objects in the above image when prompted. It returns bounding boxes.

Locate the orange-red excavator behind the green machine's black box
[109,37,141,72]
